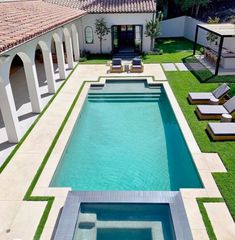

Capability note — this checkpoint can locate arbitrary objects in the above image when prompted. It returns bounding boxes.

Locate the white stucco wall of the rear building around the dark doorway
[79,13,152,53]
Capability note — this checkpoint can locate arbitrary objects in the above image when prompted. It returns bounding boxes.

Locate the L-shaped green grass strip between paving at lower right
[197,198,224,240]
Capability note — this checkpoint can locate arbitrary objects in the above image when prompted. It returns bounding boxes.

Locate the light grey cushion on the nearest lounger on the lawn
[208,122,235,136]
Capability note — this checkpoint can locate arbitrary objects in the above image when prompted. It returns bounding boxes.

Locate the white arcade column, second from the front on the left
[24,61,42,113]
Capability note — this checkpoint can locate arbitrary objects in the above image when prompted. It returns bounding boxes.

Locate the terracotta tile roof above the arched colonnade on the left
[0,1,86,53]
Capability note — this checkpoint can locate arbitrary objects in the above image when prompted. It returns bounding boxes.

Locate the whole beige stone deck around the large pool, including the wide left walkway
[0,64,235,240]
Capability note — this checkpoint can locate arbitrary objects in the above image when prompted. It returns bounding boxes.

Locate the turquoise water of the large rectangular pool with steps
[51,81,202,190]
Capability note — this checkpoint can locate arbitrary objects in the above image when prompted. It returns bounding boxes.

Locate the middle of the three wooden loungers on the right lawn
[196,96,235,119]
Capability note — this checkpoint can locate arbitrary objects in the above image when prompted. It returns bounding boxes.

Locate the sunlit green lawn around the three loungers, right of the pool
[166,72,235,219]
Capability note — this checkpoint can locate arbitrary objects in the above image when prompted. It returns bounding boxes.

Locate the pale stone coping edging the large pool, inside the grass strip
[32,76,226,239]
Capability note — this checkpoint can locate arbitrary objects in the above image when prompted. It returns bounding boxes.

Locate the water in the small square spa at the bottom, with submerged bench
[74,203,175,240]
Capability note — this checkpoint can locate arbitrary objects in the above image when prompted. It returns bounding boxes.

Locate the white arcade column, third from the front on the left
[43,50,56,93]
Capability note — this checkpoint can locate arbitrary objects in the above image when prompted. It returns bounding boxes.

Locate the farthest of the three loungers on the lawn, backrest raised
[188,83,230,104]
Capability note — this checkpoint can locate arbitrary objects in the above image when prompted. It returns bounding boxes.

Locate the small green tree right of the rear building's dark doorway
[145,12,163,51]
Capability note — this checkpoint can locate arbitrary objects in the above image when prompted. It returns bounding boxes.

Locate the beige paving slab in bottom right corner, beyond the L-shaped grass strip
[204,202,235,240]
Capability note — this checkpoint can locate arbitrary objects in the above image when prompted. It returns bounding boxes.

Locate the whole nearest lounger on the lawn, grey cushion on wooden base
[207,122,235,141]
